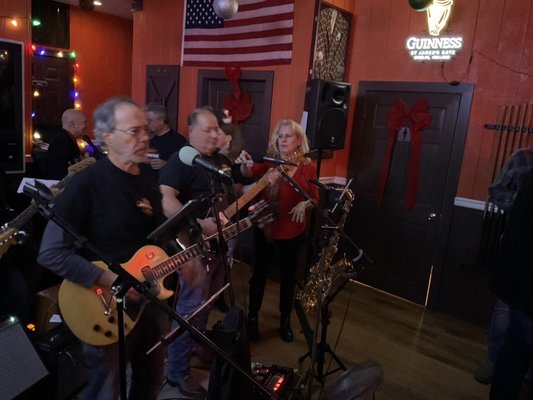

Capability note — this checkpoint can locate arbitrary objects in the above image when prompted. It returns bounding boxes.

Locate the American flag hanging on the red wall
[182,0,294,67]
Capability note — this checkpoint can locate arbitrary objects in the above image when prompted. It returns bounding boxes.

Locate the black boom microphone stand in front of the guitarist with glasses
[24,185,279,400]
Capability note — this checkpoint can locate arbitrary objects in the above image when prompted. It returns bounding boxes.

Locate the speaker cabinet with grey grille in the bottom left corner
[0,318,48,399]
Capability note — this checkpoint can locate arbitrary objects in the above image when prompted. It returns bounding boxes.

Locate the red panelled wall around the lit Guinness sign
[336,0,533,200]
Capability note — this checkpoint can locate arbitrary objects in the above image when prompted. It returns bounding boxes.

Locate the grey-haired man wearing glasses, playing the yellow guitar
[38,97,168,400]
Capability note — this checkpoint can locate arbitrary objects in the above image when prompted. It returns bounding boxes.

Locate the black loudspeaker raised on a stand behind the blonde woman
[304,79,351,149]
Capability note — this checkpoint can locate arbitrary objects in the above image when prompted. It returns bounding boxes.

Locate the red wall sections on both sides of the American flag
[132,0,314,145]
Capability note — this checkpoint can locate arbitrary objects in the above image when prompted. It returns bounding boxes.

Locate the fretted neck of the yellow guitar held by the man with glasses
[148,218,252,279]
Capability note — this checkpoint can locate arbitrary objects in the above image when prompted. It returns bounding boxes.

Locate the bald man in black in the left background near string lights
[46,109,87,180]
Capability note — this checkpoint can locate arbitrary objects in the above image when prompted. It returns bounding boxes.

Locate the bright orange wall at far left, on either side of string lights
[0,0,133,154]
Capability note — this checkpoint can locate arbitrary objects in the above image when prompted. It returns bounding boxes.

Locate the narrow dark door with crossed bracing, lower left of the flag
[146,65,180,130]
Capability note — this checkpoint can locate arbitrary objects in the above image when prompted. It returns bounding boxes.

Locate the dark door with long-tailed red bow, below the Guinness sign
[346,82,473,304]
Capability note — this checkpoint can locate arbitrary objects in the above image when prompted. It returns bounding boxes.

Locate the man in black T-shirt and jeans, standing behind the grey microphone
[159,108,233,398]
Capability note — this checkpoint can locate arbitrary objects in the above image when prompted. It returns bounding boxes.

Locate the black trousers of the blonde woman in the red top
[250,228,302,315]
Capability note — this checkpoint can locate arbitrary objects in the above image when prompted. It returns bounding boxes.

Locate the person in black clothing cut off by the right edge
[490,170,533,400]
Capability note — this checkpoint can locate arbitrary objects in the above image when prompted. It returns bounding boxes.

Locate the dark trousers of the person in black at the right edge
[490,307,533,400]
